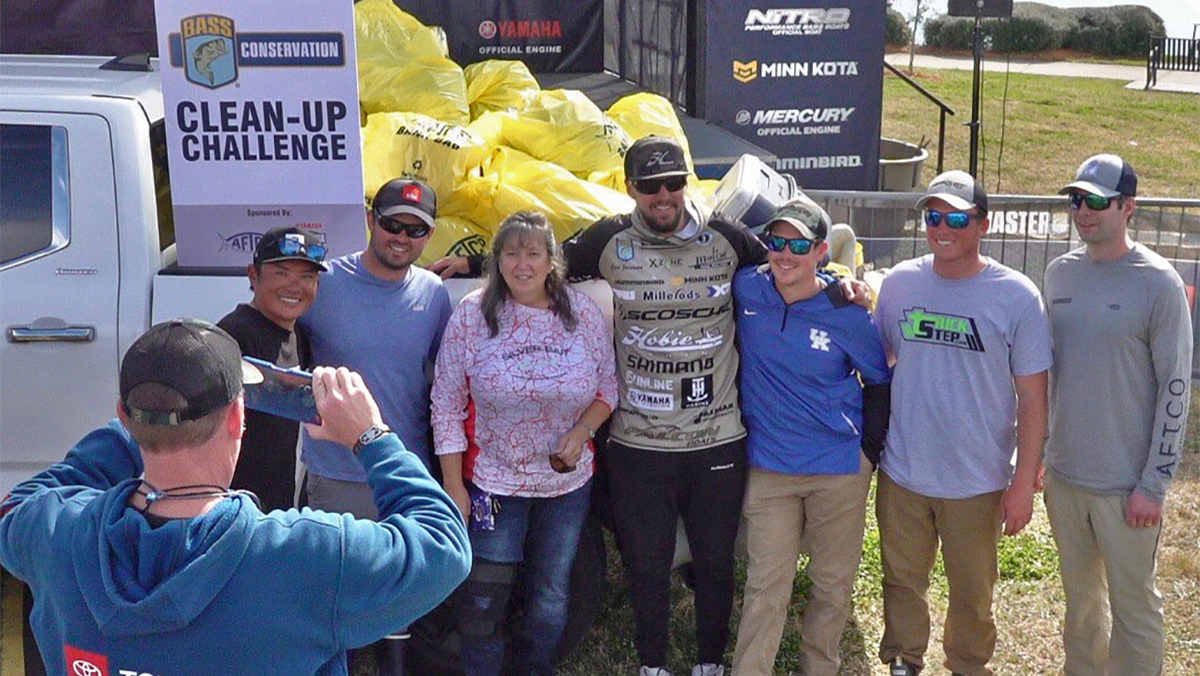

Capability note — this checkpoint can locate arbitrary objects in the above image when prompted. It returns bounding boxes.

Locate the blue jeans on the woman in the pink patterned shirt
[461,480,592,676]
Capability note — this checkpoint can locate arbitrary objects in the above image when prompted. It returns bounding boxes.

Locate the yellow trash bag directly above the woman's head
[443,146,634,241]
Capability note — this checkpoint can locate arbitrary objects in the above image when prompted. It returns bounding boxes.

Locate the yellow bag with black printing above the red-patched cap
[362,113,487,207]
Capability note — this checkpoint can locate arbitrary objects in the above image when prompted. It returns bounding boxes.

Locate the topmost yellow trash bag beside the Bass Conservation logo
[354,0,470,125]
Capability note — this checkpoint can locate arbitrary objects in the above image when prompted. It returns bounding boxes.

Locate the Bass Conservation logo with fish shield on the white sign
[167,14,346,89]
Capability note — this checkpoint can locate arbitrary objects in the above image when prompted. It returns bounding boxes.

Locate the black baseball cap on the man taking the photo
[120,318,263,425]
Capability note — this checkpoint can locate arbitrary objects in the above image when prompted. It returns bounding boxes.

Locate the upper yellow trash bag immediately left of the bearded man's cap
[504,89,631,178]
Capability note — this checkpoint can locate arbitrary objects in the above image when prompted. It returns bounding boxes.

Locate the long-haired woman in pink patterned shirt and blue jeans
[432,211,617,676]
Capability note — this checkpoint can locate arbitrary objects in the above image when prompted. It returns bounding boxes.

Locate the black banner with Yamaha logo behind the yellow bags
[395,0,604,73]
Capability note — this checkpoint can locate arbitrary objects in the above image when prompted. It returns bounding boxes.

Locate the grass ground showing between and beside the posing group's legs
[559,388,1200,676]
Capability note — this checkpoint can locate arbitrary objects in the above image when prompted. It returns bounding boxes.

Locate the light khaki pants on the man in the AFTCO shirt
[1045,472,1163,676]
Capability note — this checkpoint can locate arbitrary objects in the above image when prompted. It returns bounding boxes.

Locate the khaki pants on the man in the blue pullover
[733,457,871,676]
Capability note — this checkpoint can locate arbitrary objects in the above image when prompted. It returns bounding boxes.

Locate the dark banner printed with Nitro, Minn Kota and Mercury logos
[704,0,886,190]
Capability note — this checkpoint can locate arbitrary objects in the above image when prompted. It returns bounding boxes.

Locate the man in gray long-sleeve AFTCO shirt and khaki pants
[1045,155,1192,676]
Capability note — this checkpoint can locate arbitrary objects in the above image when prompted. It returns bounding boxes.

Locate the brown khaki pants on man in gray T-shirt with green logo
[875,472,1003,676]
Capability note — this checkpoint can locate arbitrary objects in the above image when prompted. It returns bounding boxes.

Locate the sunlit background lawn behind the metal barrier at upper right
[883,68,1200,198]
